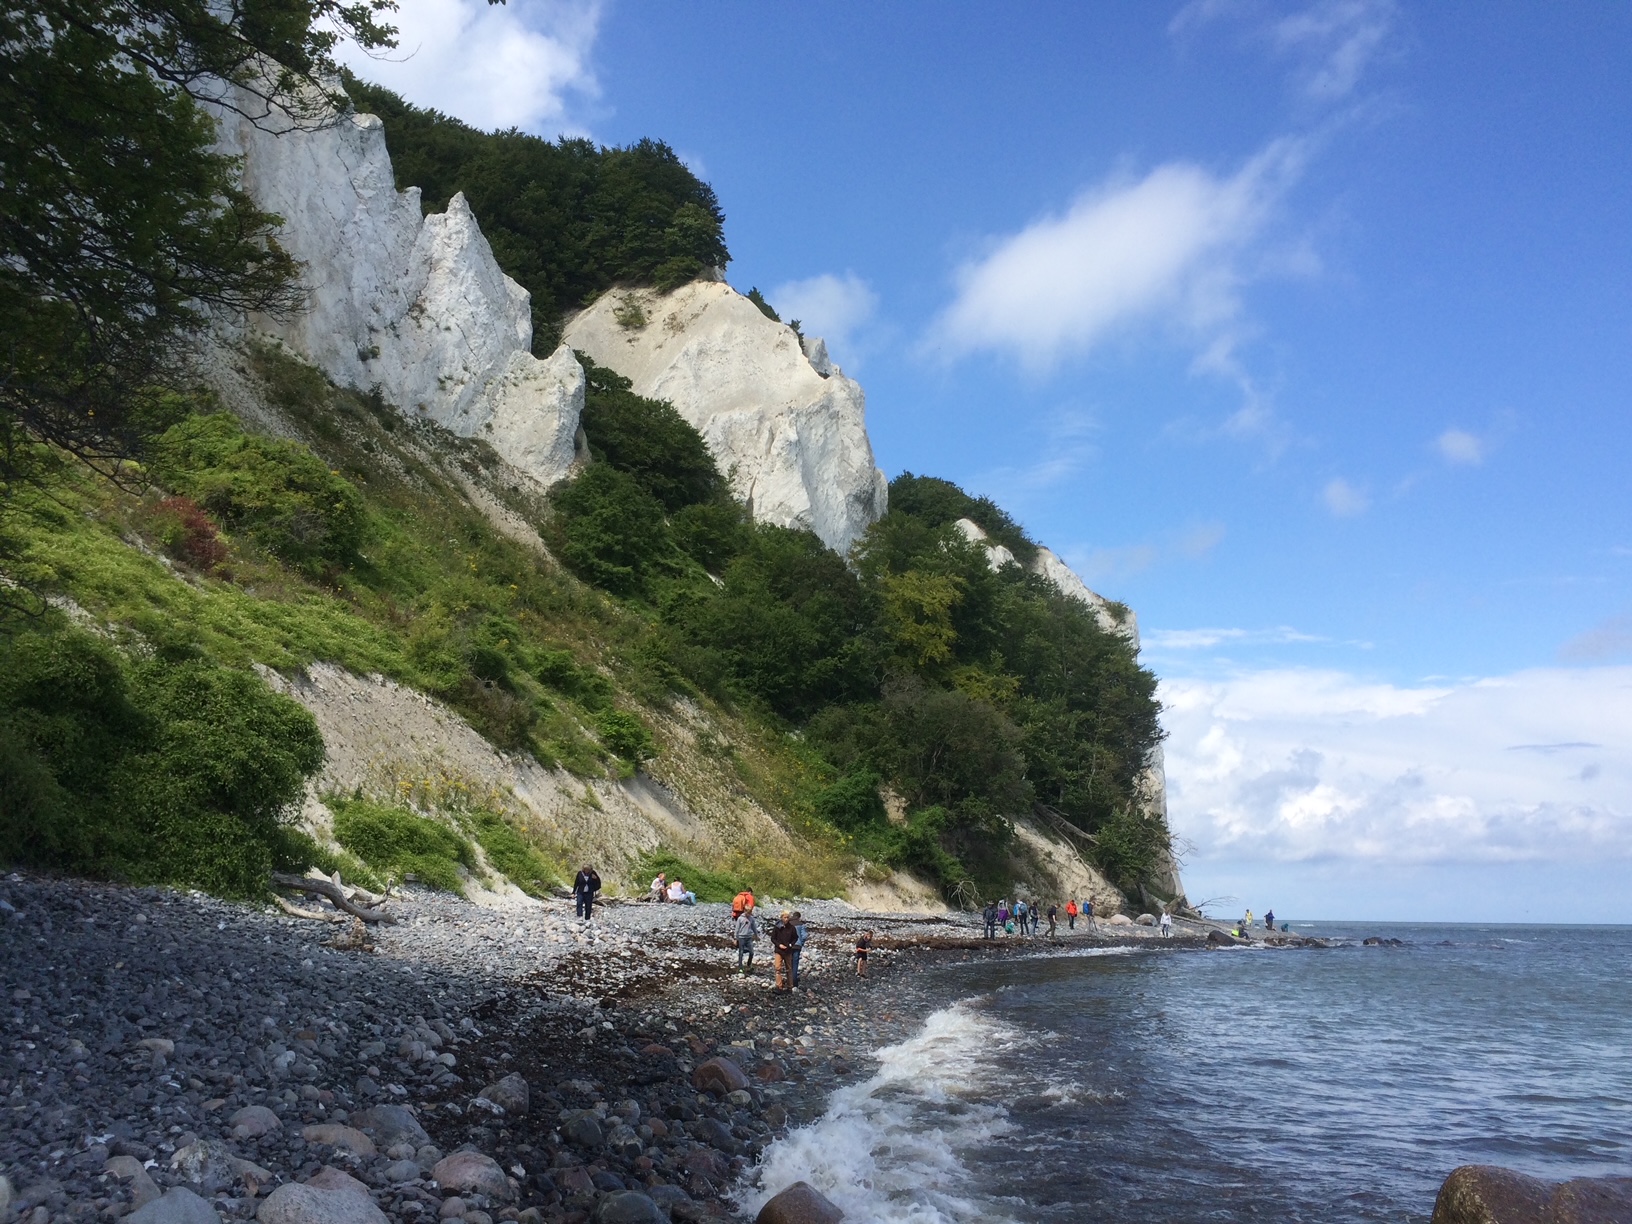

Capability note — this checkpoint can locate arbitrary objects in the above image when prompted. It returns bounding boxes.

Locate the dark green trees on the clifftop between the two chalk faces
[346,77,731,354]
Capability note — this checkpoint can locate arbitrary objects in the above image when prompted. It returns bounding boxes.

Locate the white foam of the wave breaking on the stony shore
[739,1004,1013,1224]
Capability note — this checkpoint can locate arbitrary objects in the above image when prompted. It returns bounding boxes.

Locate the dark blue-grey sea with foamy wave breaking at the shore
[741,922,1632,1224]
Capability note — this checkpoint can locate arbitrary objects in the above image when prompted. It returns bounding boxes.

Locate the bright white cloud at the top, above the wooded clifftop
[339,0,601,137]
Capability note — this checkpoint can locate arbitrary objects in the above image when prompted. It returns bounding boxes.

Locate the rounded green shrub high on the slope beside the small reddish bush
[150,413,367,574]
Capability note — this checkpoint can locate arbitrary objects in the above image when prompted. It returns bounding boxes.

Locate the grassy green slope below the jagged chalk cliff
[3,348,849,894]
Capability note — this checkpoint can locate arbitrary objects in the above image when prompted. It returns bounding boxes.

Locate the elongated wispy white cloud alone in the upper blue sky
[935,139,1306,369]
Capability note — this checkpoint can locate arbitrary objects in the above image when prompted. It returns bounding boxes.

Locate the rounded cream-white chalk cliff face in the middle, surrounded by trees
[566,281,889,553]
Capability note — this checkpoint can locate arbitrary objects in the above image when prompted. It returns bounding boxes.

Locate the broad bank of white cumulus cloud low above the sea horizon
[1160,667,1632,865]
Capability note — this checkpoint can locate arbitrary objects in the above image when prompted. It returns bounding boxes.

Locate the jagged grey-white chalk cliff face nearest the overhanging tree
[208,98,584,485]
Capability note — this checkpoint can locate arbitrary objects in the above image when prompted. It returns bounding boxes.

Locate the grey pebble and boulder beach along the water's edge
[0,875,1227,1224]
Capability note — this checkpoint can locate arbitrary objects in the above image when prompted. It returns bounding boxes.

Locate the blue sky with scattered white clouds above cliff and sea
[334,0,1632,920]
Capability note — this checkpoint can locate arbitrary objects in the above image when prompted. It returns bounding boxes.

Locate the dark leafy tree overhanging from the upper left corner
[0,0,393,498]
